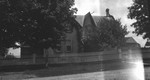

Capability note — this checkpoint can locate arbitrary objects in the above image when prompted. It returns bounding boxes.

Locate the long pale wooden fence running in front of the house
[0,50,141,66]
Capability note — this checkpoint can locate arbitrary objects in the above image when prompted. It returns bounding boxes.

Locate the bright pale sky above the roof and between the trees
[75,0,146,46]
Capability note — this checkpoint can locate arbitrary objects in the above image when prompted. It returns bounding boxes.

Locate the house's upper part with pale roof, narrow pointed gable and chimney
[76,9,114,39]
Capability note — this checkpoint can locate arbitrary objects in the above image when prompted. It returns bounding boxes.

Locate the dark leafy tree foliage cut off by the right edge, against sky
[128,0,150,38]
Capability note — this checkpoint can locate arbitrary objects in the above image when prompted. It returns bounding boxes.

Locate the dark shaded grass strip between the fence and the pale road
[0,60,134,78]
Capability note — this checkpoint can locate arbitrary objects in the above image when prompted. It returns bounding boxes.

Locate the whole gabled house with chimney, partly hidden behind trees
[21,9,132,57]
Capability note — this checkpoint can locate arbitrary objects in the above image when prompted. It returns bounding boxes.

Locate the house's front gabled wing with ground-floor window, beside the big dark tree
[56,20,82,54]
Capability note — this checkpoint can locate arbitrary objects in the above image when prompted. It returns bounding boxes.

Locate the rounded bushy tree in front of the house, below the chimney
[86,18,128,51]
